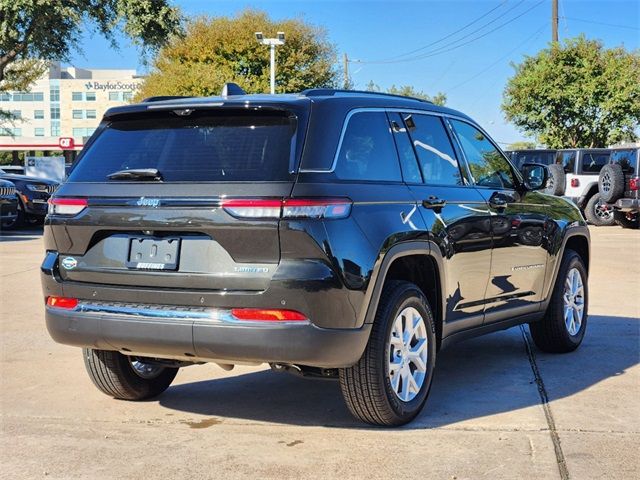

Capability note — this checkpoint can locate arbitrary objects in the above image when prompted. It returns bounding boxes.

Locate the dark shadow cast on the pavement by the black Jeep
[159,316,640,429]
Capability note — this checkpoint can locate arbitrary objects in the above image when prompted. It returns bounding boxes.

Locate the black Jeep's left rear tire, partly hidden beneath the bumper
[82,348,178,400]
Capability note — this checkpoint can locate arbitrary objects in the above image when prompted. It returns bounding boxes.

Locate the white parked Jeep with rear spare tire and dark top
[547,148,614,226]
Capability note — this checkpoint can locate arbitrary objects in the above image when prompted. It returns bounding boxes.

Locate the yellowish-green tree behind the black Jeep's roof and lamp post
[137,10,339,100]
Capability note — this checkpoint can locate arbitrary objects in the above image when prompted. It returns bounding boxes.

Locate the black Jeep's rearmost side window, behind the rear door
[335,112,402,182]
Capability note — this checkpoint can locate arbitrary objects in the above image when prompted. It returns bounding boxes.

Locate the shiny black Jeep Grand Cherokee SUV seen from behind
[42,86,589,425]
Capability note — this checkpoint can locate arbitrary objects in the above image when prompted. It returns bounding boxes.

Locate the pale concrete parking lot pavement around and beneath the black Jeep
[0,227,640,479]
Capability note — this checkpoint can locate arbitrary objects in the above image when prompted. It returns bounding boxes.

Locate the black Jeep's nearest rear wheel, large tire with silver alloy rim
[339,281,436,426]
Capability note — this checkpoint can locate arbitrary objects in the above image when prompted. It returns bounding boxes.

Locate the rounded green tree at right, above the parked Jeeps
[502,36,640,148]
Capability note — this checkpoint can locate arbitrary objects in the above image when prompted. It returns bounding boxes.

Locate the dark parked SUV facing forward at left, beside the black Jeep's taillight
[0,168,58,228]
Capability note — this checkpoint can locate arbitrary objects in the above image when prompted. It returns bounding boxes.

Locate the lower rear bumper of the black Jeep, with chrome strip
[46,304,371,368]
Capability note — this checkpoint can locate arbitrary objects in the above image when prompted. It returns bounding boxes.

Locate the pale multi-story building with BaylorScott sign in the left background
[0,63,142,158]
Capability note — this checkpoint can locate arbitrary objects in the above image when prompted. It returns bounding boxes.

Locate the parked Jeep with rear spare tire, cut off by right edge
[598,148,640,228]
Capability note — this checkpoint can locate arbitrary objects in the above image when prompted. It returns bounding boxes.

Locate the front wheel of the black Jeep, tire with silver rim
[529,249,589,353]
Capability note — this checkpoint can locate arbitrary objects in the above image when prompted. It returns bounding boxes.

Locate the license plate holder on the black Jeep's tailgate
[127,237,180,270]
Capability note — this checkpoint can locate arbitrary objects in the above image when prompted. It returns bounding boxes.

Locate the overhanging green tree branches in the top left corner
[0,0,181,82]
